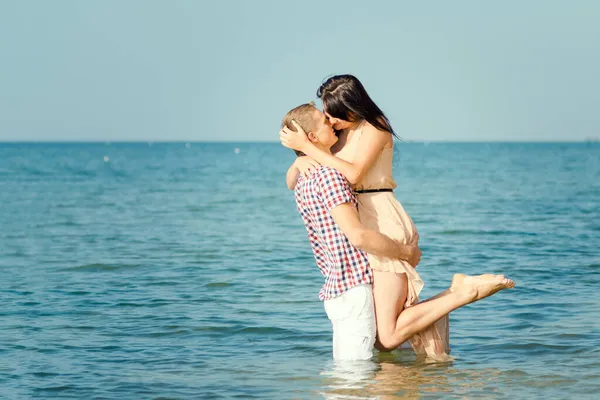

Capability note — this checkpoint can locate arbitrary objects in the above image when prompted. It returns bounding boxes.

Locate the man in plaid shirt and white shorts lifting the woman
[282,104,421,360]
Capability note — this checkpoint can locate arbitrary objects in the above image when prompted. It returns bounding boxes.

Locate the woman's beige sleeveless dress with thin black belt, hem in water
[336,128,450,360]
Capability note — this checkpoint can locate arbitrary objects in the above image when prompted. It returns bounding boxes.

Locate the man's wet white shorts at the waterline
[323,285,377,360]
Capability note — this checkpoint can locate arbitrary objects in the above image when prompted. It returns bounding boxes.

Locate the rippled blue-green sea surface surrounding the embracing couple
[0,142,600,399]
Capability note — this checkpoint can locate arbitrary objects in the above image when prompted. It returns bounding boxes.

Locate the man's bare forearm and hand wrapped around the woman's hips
[331,203,421,267]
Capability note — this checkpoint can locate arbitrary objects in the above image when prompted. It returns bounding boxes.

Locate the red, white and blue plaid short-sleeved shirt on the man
[296,167,373,300]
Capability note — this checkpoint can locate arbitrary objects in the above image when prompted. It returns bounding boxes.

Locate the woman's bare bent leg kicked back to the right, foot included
[373,271,514,350]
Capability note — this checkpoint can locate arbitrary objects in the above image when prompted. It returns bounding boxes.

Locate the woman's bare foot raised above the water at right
[450,274,515,304]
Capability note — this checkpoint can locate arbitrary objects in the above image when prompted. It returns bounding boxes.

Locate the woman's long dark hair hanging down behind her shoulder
[317,75,398,138]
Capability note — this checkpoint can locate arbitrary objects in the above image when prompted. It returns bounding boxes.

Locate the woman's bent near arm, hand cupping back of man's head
[281,121,390,185]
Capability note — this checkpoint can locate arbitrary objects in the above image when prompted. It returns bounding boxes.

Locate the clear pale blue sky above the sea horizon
[0,0,600,141]
